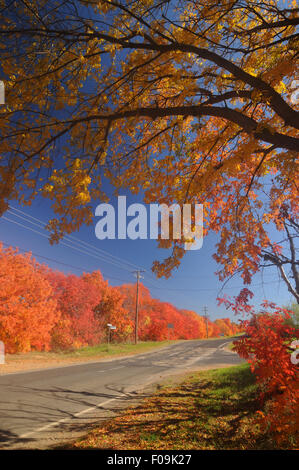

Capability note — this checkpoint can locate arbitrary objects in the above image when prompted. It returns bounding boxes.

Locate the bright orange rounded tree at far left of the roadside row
[0,244,60,353]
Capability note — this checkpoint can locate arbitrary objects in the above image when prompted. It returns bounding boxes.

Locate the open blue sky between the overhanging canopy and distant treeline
[0,192,292,320]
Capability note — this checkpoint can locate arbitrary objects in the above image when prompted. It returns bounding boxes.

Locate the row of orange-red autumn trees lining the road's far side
[0,244,240,353]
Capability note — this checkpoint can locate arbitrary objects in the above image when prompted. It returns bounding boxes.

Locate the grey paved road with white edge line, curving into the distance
[0,338,241,449]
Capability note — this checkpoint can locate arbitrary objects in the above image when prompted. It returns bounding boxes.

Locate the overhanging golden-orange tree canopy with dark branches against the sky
[0,0,299,300]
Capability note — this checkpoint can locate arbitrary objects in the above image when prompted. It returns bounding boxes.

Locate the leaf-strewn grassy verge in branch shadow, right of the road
[64,364,284,450]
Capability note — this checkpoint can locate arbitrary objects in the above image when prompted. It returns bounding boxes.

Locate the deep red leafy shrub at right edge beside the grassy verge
[225,299,299,446]
